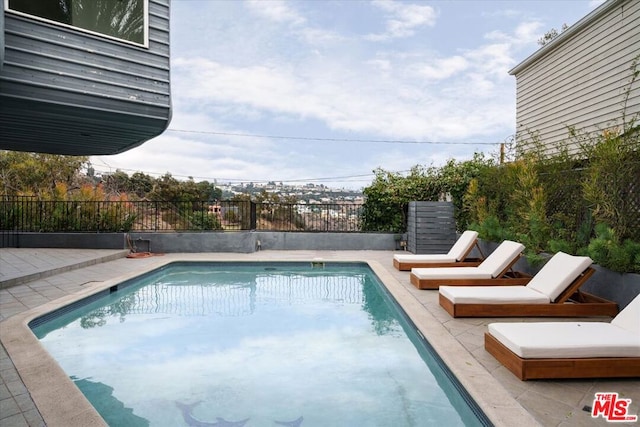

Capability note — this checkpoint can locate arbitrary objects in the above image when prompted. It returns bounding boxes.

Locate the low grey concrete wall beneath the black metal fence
[12,231,397,253]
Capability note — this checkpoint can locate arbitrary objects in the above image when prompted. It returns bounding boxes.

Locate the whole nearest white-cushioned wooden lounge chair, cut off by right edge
[484,295,640,380]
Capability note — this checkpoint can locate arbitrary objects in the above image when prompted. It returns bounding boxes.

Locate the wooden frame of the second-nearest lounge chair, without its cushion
[439,267,618,317]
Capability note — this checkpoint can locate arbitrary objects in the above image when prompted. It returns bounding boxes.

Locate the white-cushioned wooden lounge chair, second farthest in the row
[410,240,531,289]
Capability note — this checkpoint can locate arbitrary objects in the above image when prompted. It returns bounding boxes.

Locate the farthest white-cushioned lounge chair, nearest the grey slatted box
[393,230,482,271]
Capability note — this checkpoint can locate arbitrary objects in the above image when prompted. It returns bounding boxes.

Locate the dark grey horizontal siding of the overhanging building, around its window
[0,0,171,155]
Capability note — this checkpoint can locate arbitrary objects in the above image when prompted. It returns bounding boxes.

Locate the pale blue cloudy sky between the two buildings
[91,0,602,190]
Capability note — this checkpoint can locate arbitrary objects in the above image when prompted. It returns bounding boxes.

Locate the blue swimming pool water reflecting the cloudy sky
[30,263,490,427]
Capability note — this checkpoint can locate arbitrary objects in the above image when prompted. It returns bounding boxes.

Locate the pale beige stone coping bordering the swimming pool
[0,254,540,427]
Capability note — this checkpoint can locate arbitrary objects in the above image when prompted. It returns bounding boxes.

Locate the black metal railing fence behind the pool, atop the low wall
[0,196,362,236]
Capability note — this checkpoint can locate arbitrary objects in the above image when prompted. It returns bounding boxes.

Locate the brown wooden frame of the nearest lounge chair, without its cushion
[484,332,640,380]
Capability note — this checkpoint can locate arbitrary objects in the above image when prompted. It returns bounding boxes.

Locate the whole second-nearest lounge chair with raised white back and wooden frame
[440,252,618,317]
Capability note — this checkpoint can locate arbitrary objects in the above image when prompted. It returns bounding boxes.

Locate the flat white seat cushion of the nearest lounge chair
[488,322,640,359]
